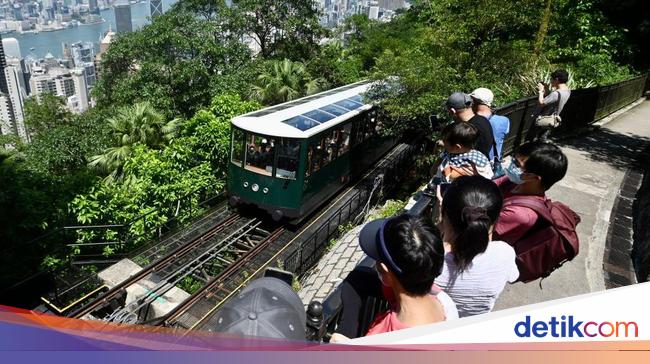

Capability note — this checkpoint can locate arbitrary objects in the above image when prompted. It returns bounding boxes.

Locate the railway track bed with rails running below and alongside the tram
[63,144,412,330]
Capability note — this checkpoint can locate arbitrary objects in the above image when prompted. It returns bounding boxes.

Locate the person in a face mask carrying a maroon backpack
[494,141,568,244]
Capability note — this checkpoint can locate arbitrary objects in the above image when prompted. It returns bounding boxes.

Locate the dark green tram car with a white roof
[227,82,395,223]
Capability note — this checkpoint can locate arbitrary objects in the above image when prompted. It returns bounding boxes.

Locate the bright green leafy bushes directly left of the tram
[67,95,259,261]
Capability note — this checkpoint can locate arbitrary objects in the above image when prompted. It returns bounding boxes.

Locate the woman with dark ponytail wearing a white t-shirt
[435,176,519,317]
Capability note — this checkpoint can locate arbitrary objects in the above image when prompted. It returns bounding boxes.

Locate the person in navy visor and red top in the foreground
[330,215,450,342]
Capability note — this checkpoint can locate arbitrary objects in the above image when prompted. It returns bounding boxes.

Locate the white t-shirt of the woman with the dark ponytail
[435,241,519,317]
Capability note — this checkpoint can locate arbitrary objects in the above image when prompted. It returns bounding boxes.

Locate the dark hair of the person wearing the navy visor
[384,215,445,296]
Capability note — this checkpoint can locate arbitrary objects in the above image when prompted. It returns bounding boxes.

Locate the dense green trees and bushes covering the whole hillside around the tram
[0,0,650,296]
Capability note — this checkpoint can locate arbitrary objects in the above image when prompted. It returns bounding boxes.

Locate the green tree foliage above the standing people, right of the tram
[346,0,630,133]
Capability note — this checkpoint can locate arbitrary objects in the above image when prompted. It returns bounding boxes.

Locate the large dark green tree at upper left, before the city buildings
[94,9,253,119]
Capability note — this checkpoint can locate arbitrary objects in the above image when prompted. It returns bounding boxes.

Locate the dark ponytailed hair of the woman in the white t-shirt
[442,176,503,271]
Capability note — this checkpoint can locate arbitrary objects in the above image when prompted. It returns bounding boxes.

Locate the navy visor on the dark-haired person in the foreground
[359,218,402,275]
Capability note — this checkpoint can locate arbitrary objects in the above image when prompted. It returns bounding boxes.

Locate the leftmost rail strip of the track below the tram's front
[68,213,248,319]
